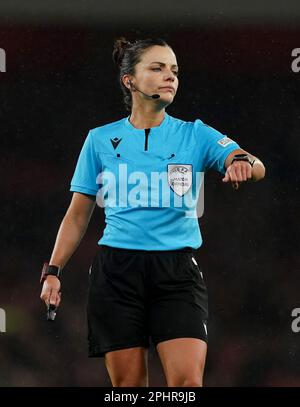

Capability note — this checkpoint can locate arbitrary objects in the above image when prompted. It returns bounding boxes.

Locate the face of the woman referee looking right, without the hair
[134,45,178,106]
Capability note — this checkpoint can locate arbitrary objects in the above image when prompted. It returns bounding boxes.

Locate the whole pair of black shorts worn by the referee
[87,245,208,357]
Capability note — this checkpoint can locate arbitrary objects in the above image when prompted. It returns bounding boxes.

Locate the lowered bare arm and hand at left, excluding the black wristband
[41,192,96,307]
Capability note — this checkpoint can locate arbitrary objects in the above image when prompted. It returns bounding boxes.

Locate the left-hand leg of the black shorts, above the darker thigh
[87,247,149,357]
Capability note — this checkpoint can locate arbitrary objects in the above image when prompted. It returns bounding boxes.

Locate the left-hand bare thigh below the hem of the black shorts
[104,347,149,387]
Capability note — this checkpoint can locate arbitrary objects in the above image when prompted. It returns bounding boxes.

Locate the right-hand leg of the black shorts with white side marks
[149,253,208,345]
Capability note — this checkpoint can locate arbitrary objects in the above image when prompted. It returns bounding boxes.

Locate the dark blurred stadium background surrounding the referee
[0,0,300,386]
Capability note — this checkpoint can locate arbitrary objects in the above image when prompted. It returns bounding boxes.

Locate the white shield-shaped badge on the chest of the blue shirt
[168,164,193,196]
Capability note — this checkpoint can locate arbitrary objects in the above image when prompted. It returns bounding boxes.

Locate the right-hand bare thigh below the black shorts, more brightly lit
[157,338,207,387]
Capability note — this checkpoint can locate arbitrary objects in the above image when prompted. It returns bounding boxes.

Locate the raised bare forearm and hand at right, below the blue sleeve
[223,149,266,189]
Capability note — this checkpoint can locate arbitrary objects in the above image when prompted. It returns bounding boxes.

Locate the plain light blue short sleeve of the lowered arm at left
[70,131,101,195]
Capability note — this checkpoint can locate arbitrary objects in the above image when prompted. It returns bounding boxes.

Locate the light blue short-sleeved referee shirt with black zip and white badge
[70,113,240,250]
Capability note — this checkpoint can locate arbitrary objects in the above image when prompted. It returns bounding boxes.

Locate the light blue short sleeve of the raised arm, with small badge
[195,120,240,174]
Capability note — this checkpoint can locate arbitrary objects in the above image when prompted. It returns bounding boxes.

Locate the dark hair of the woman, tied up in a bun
[112,37,170,111]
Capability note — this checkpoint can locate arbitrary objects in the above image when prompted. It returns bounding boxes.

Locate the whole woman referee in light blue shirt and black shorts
[41,38,265,387]
